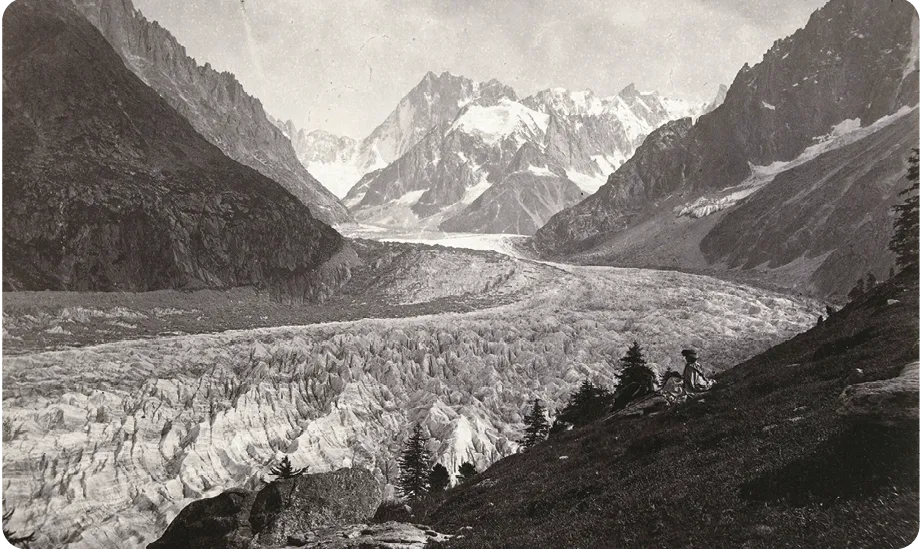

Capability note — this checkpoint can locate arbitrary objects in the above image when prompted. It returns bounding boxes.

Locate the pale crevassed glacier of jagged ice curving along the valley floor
[0,234,820,550]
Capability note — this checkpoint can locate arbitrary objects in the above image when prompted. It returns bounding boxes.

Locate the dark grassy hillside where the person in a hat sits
[417,276,919,550]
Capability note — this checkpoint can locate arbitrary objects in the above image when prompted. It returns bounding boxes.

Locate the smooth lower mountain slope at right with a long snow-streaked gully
[552,108,919,296]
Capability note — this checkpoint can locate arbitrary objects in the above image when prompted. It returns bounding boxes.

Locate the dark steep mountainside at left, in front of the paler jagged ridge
[2,0,343,298]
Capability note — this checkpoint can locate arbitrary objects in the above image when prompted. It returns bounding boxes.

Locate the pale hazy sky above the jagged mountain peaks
[135,0,824,138]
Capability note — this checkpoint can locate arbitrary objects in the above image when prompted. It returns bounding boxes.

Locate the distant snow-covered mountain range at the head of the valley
[276,72,726,234]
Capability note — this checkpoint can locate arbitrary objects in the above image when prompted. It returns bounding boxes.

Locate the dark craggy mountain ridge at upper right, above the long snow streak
[534,0,919,293]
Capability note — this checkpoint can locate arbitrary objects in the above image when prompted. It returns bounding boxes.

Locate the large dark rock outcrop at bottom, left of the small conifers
[147,468,382,550]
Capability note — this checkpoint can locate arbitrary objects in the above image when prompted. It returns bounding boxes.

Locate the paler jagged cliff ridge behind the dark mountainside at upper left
[74,0,351,223]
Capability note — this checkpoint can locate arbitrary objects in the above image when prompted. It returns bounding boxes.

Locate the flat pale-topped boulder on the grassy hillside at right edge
[837,361,919,425]
